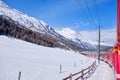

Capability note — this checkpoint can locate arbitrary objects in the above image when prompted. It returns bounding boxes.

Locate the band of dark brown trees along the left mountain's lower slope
[0,15,80,51]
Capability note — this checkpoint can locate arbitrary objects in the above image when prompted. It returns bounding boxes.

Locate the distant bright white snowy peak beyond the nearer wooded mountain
[56,28,97,49]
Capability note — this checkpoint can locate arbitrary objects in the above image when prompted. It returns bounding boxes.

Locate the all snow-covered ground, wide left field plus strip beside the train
[0,36,114,80]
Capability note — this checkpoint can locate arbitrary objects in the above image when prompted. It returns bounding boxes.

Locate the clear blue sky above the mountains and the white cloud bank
[3,0,117,31]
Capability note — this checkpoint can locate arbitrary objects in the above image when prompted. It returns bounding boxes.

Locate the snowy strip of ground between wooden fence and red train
[88,62,115,80]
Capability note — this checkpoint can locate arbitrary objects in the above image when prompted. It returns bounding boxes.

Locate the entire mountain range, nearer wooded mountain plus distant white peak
[0,0,110,51]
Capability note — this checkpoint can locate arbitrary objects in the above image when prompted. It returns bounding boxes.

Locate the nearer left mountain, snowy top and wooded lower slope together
[0,0,83,50]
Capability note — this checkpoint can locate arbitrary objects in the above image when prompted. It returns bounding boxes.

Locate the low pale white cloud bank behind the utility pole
[80,29,116,44]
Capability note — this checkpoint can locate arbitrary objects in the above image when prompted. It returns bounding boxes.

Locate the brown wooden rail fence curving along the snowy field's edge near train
[63,61,96,80]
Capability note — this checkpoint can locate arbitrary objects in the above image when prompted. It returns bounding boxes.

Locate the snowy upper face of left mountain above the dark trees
[0,0,56,34]
